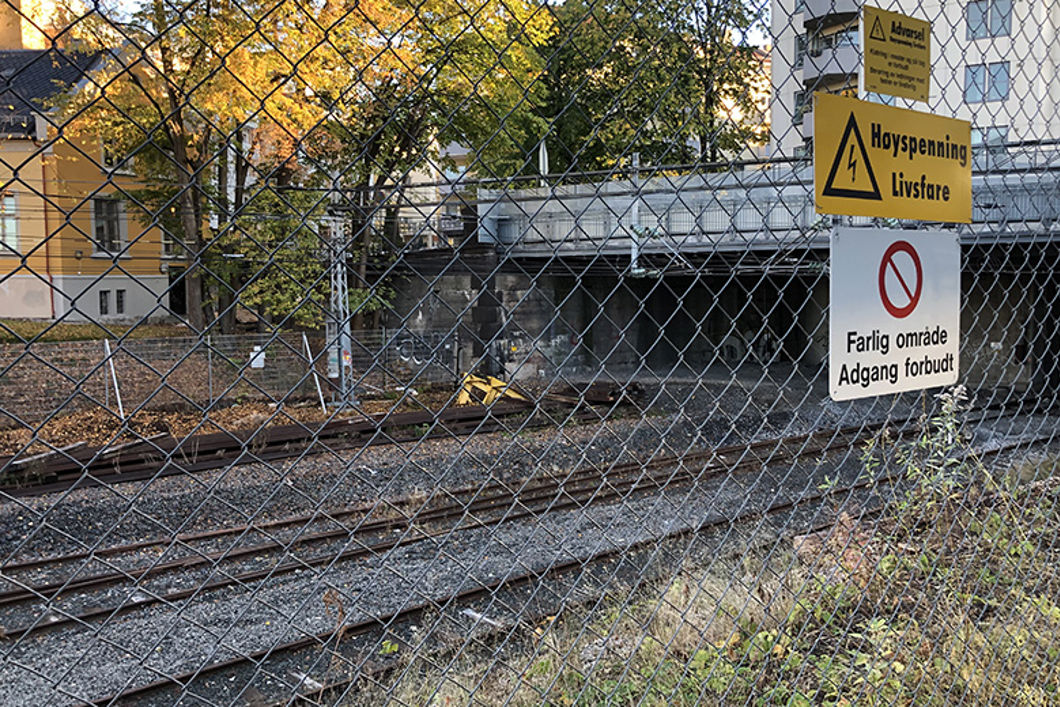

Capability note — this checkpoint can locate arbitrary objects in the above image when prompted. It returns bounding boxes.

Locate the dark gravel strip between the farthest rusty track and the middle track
[0,372,962,562]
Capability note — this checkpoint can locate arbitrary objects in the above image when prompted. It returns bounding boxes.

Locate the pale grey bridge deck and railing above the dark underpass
[478,162,1060,267]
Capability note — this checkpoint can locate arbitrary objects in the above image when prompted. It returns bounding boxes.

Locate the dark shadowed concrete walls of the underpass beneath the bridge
[399,250,1047,389]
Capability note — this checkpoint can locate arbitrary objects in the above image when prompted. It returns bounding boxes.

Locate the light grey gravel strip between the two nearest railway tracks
[0,396,1057,705]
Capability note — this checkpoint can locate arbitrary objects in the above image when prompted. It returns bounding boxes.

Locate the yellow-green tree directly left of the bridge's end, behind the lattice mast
[294,0,551,329]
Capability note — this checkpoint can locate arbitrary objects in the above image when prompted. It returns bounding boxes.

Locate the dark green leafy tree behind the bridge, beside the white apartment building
[543,0,769,171]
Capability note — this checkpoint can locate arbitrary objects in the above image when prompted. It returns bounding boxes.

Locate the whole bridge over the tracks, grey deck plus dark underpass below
[398,157,1060,396]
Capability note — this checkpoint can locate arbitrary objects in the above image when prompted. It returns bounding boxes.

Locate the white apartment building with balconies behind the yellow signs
[771,0,1060,157]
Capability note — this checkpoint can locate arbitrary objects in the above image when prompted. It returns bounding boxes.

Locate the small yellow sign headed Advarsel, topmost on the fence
[862,5,931,101]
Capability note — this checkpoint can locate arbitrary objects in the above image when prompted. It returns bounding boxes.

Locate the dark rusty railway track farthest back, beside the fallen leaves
[0,386,629,497]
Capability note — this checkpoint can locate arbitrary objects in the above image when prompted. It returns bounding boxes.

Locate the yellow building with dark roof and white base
[0,9,170,321]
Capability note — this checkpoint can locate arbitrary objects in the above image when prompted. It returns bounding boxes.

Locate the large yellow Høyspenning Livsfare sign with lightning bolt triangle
[813,93,972,224]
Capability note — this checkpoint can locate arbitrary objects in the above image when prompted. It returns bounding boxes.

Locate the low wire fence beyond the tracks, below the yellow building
[0,330,460,428]
